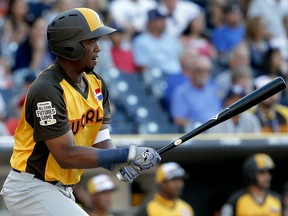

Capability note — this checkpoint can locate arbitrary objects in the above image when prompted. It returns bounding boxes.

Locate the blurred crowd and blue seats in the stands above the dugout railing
[0,0,288,135]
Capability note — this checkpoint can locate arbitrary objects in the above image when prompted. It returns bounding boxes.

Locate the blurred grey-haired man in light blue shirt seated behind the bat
[170,52,222,131]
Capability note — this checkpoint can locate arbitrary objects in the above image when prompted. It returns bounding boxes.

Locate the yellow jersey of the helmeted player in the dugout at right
[221,190,282,216]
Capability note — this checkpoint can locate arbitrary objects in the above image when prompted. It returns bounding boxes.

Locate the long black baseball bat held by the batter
[157,77,286,155]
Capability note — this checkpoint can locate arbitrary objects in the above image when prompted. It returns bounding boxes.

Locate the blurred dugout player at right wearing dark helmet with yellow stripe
[221,154,282,216]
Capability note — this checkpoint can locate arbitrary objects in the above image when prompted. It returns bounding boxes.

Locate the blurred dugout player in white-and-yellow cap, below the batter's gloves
[136,162,194,216]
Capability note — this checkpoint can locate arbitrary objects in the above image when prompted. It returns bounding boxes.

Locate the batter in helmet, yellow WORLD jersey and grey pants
[1,8,161,216]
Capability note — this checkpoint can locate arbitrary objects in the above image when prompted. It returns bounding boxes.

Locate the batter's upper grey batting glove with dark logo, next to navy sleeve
[128,144,161,170]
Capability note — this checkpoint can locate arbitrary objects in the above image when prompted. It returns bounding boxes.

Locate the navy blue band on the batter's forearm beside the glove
[97,148,129,170]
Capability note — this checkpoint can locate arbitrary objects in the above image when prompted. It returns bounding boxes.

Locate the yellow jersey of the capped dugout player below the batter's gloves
[138,194,194,216]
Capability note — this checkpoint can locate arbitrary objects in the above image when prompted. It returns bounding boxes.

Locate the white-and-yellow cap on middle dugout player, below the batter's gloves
[156,162,187,184]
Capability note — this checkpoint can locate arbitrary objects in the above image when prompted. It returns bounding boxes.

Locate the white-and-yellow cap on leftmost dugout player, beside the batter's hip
[87,174,116,195]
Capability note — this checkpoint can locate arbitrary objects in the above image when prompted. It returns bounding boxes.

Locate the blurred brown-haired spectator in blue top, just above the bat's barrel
[246,16,270,76]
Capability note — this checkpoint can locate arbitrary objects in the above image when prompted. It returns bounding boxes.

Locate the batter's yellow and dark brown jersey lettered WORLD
[10,63,111,185]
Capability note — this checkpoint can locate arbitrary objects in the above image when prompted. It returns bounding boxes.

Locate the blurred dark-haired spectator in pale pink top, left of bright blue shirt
[180,13,216,59]
